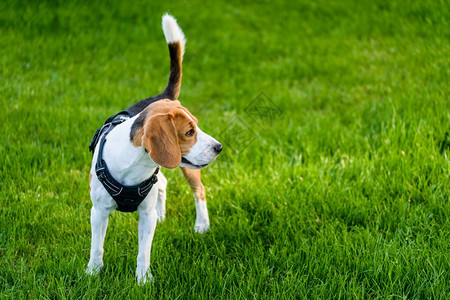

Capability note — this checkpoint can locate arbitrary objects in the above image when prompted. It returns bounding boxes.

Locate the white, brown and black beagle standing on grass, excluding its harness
[86,14,222,284]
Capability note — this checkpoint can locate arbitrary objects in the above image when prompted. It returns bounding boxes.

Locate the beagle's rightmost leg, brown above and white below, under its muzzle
[181,168,209,233]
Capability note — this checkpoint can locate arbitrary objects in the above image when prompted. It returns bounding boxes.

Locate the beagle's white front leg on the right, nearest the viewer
[136,207,158,284]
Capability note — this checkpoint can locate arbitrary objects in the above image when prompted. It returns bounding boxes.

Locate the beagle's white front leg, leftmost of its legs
[86,206,111,275]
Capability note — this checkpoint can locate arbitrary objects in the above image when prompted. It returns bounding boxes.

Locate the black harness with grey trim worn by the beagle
[89,111,159,212]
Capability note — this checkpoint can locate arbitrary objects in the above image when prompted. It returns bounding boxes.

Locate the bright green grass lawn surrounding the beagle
[0,0,450,299]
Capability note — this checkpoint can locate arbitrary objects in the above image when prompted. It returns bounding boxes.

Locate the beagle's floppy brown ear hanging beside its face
[142,114,181,169]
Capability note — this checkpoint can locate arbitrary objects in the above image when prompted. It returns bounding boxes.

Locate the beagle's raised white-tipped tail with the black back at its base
[127,14,186,116]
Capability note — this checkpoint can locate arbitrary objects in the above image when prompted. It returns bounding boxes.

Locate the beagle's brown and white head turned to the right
[130,100,222,169]
